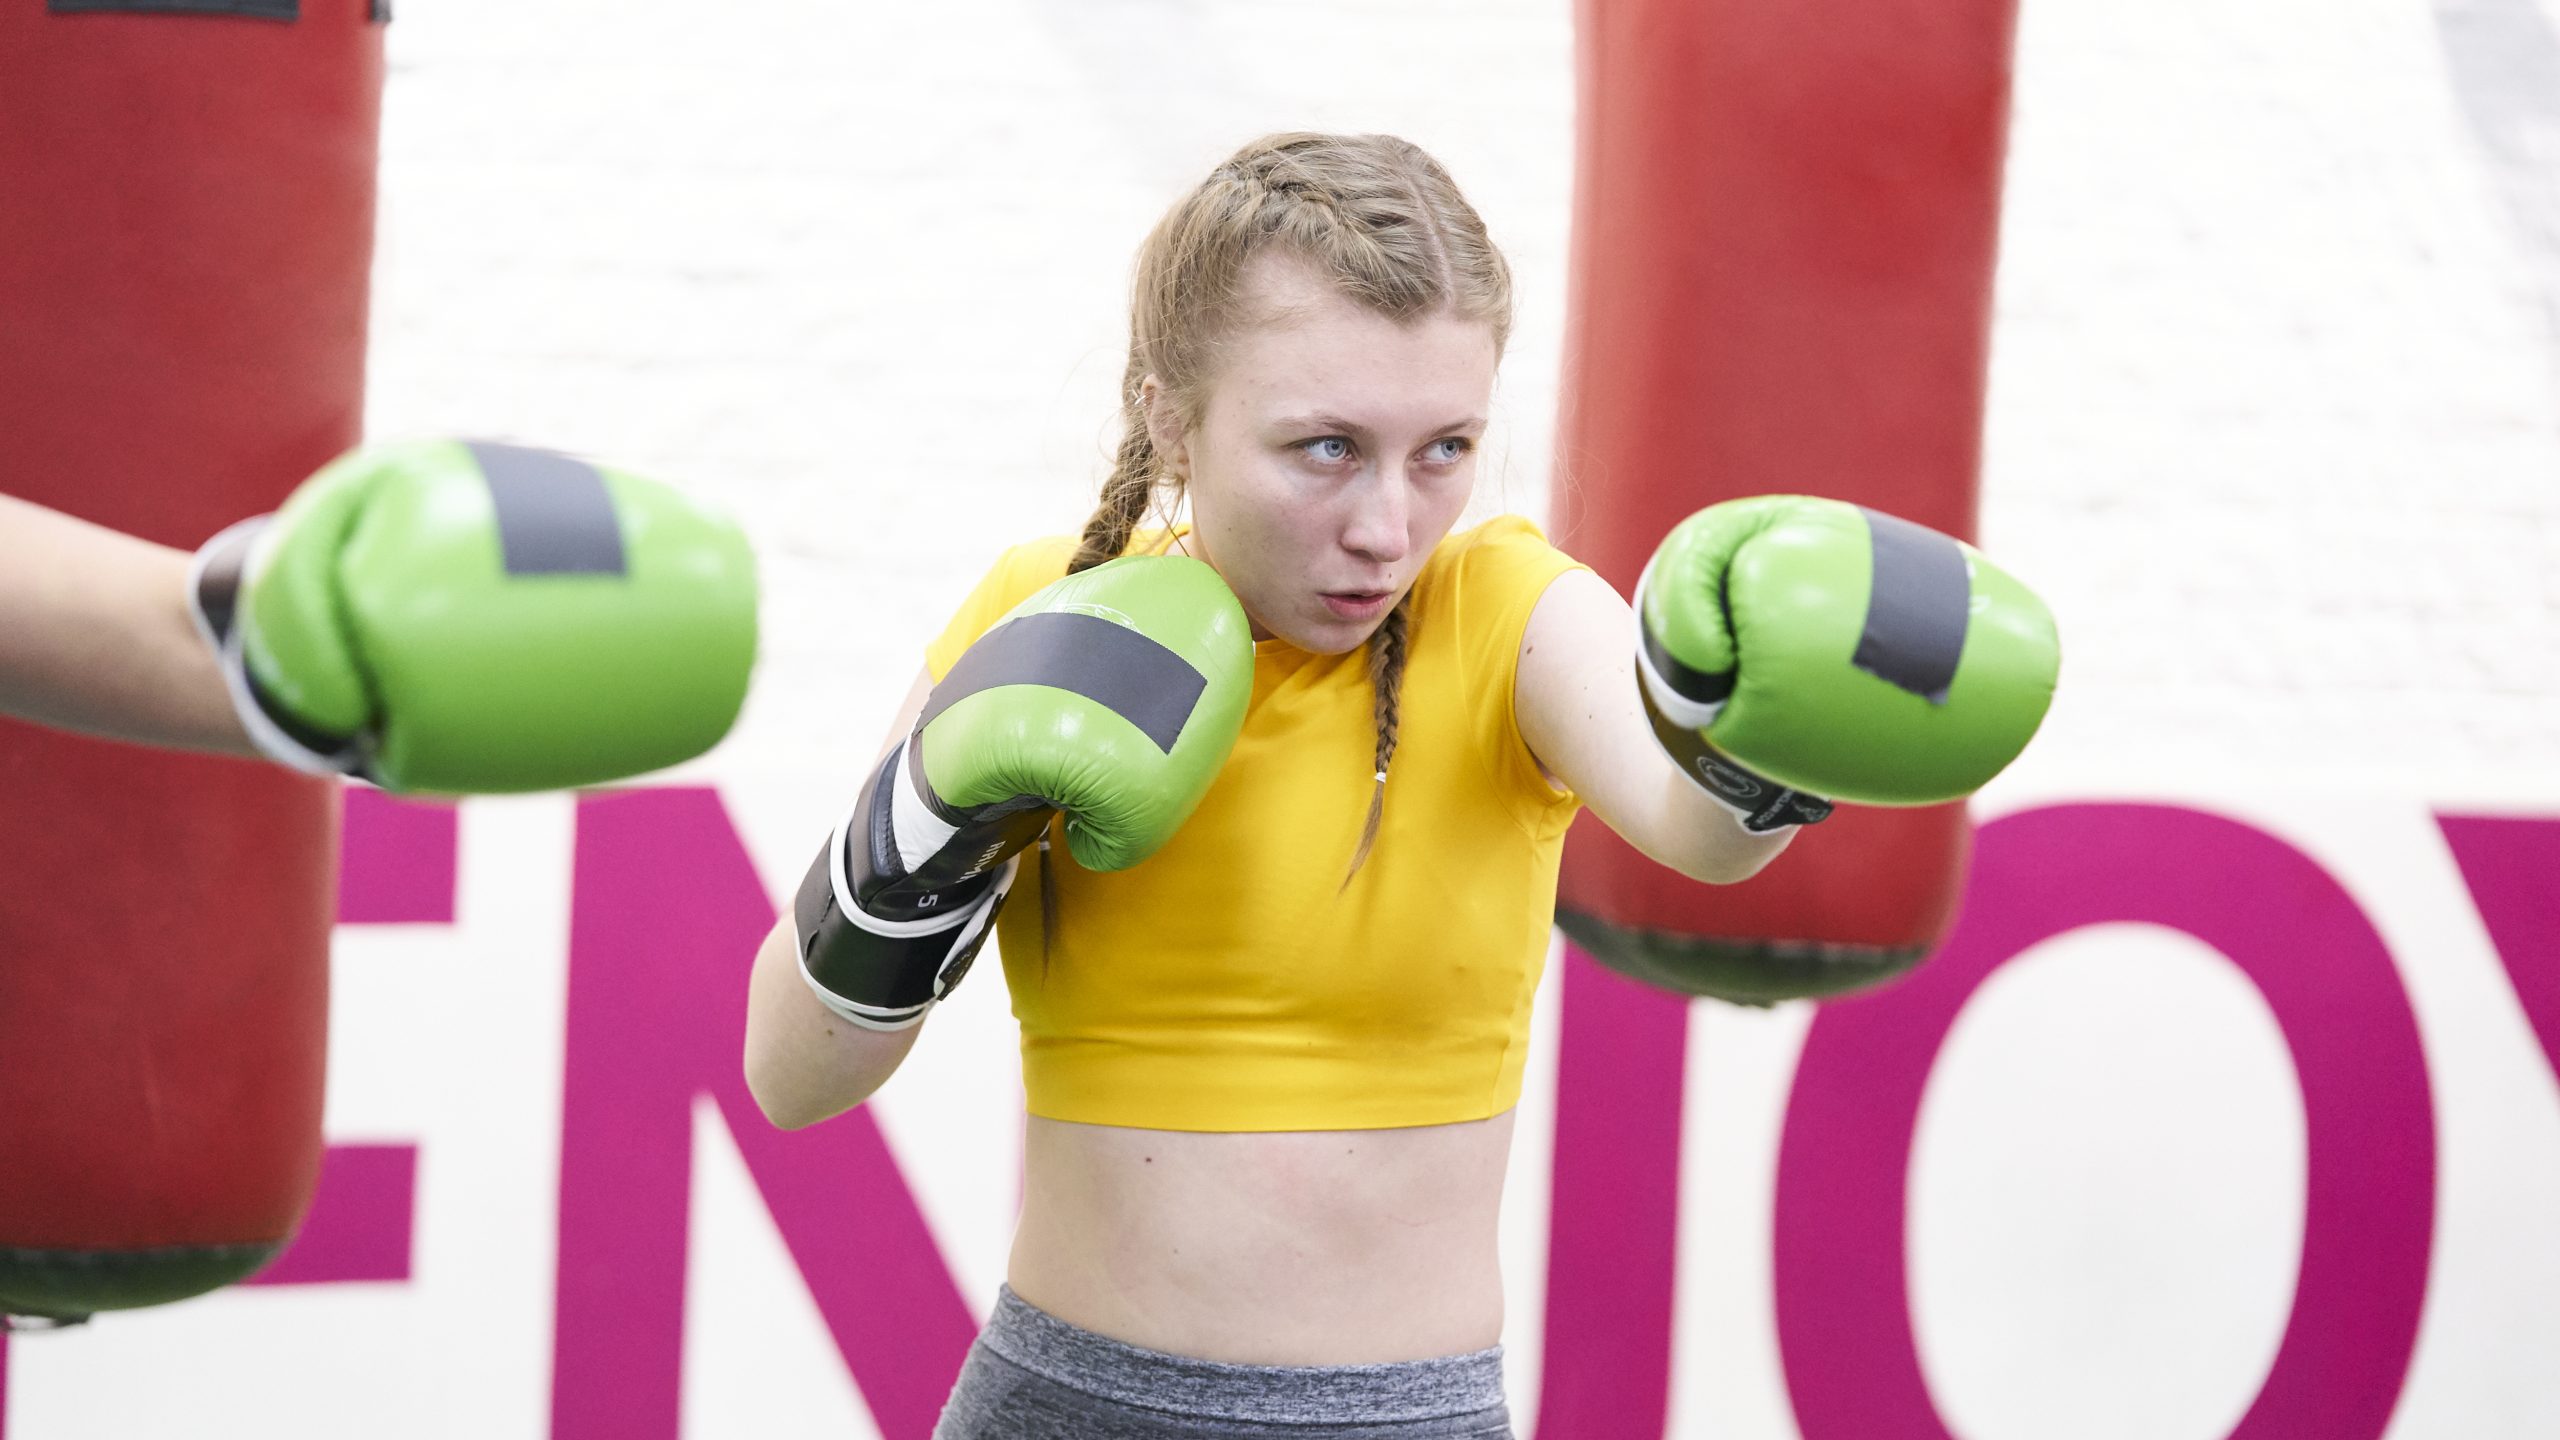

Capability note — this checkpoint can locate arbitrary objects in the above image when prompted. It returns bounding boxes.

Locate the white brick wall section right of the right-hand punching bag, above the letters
[1984,0,2560,799]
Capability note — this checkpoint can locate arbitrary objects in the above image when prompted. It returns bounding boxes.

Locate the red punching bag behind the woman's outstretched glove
[1556,0,2015,1002]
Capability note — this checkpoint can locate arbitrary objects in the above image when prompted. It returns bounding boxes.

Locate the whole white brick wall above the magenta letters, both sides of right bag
[369,0,2560,794]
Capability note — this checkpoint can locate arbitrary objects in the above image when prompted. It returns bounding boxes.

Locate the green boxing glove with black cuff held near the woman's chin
[791,556,1254,1030]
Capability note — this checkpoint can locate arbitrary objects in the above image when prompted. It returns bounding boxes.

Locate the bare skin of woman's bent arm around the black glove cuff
[748,671,934,1130]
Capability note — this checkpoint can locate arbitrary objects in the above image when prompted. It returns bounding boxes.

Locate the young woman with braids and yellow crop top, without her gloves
[748,136,1815,1440]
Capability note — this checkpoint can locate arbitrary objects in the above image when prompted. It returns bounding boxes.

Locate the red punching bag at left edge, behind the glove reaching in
[0,0,381,1317]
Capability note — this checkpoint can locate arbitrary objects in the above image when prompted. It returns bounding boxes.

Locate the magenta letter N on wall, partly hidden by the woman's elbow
[550,789,978,1440]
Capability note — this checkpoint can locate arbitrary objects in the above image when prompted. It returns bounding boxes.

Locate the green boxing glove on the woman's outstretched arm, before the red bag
[1636,495,2061,830]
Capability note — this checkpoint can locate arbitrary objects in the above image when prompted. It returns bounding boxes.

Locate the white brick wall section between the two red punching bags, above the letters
[369,0,1572,809]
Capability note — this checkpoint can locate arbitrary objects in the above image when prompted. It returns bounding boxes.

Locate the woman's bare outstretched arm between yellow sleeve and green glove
[1513,569,1795,884]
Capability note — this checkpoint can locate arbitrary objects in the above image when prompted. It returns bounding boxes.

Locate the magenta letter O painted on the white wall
[1777,805,2435,1440]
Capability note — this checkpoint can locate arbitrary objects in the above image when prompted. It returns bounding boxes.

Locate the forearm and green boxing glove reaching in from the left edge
[0,441,755,794]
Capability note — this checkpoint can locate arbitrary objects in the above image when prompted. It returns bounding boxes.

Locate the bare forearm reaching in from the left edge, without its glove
[0,495,256,756]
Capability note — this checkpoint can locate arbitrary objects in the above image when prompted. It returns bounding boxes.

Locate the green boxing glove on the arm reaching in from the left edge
[189,441,755,794]
